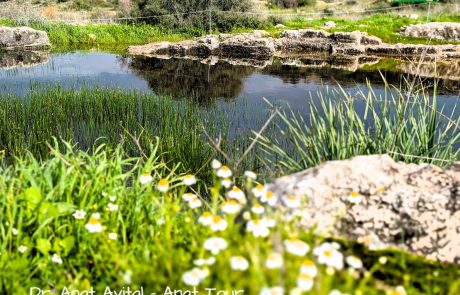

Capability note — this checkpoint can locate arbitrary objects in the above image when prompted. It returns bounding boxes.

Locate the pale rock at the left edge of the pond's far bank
[0,27,51,50]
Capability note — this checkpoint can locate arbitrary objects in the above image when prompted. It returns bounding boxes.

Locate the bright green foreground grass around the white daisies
[0,143,460,295]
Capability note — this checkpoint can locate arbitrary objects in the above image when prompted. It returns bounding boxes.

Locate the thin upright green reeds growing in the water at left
[0,87,230,178]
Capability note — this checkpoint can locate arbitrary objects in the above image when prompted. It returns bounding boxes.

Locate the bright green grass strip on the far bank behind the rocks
[4,14,460,51]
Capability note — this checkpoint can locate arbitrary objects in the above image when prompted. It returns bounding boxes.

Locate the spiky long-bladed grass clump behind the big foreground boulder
[262,80,460,172]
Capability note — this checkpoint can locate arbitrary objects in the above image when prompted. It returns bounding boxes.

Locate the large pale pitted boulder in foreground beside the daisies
[268,155,460,263]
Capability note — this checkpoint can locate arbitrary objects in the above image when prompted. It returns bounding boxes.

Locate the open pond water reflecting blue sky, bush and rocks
[0,51,460,147]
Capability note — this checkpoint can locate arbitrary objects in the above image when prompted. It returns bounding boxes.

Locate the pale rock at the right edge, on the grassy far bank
[400,22,460,41]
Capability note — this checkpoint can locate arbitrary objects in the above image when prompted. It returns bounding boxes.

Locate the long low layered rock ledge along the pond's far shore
[128,29,460,64]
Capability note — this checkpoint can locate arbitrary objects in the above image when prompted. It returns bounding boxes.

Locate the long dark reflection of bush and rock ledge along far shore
[120,57,460,104]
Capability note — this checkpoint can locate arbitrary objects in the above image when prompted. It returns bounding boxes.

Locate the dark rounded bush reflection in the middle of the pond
[128,57,257,104]
